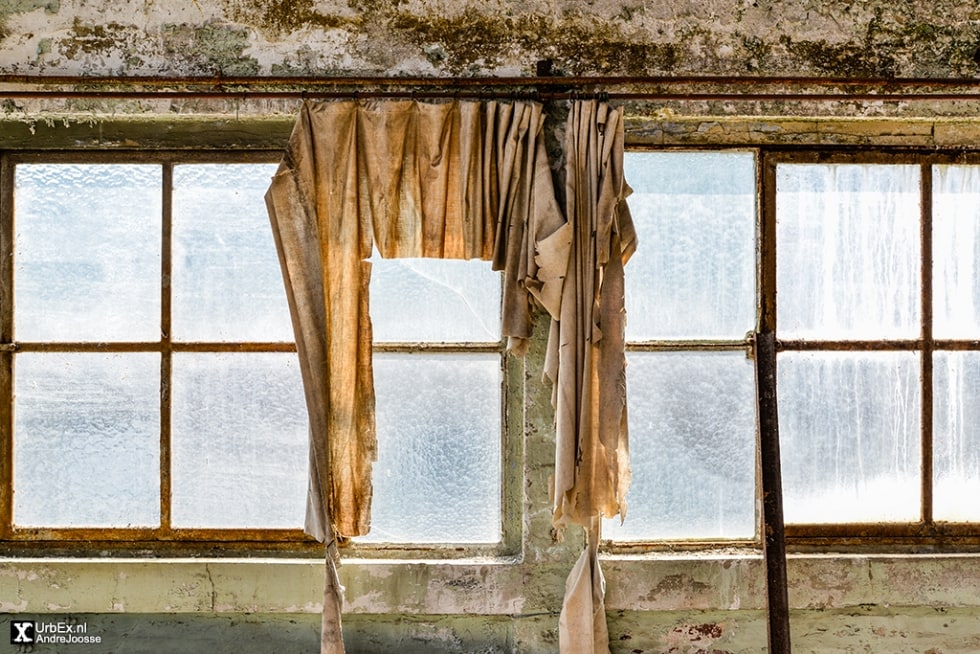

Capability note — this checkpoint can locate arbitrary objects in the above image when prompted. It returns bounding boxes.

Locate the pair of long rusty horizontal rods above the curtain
[0,75,980,102]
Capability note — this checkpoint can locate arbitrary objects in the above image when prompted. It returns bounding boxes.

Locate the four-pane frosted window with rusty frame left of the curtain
[2,155,314,544]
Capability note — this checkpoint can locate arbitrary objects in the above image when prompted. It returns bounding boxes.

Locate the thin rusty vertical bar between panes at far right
[919,162,934,524]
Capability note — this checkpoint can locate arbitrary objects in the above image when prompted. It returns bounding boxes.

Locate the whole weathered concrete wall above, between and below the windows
[0,0,980,654]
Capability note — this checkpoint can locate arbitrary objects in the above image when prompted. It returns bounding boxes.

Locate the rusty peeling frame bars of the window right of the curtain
[605,145,980,553]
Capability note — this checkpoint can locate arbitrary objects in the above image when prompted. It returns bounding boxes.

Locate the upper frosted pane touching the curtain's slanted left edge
[173,164,293,342]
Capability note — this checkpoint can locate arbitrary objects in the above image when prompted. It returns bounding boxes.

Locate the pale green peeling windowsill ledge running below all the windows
[7,553,980,615]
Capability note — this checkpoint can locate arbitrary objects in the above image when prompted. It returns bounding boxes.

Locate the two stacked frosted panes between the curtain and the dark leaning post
[604,152,757,541]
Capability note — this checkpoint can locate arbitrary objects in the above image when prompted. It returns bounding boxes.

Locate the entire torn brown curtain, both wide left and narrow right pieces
[266,101,632,652]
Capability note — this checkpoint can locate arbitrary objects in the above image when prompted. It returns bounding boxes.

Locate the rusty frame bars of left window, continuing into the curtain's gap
[0,148,524,559]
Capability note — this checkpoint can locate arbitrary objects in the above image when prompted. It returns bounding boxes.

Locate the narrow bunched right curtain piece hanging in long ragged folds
[545,101,636,654]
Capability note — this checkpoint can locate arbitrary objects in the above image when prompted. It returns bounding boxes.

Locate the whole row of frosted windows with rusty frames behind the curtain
[11,148,980,553]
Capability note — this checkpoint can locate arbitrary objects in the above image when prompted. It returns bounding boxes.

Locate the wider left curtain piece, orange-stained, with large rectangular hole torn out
[266,101,567,653]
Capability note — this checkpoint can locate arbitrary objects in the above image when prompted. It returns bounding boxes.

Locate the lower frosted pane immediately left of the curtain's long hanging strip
[171,352,308,529]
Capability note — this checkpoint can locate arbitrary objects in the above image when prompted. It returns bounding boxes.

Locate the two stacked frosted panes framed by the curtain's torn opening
[364,257,504,545]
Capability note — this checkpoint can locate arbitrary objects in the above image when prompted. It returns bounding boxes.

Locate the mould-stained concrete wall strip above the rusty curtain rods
[0,0,980,77]
